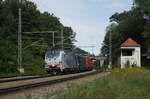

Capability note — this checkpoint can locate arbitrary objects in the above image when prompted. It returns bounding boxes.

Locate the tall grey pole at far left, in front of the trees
[18,0,24,73]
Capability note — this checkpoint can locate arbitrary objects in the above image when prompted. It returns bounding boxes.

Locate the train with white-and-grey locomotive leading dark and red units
[45,51,93,74]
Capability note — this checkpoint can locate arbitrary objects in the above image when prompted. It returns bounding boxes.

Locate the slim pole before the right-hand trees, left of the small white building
[108,31,112,69]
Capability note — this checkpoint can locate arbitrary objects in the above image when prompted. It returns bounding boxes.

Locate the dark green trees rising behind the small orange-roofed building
[101,0,150,66]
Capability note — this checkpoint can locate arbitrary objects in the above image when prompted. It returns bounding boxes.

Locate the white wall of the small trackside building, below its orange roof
[121,47,141,68]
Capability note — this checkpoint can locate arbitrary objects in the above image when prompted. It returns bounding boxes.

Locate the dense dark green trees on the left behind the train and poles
[0,0,75,75]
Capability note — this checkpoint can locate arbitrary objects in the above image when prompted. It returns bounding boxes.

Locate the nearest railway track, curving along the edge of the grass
[0,71,99,95]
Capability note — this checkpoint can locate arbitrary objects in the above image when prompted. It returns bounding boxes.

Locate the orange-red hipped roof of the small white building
[121,38,140,47]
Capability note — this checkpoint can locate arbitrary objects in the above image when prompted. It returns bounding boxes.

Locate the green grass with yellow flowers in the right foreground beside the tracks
[53,68,150,99]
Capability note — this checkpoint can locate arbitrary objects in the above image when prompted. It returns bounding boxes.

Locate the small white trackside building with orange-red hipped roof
[121,38,141,68]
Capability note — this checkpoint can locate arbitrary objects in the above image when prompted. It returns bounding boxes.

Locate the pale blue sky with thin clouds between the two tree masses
[30,0,132,55]
